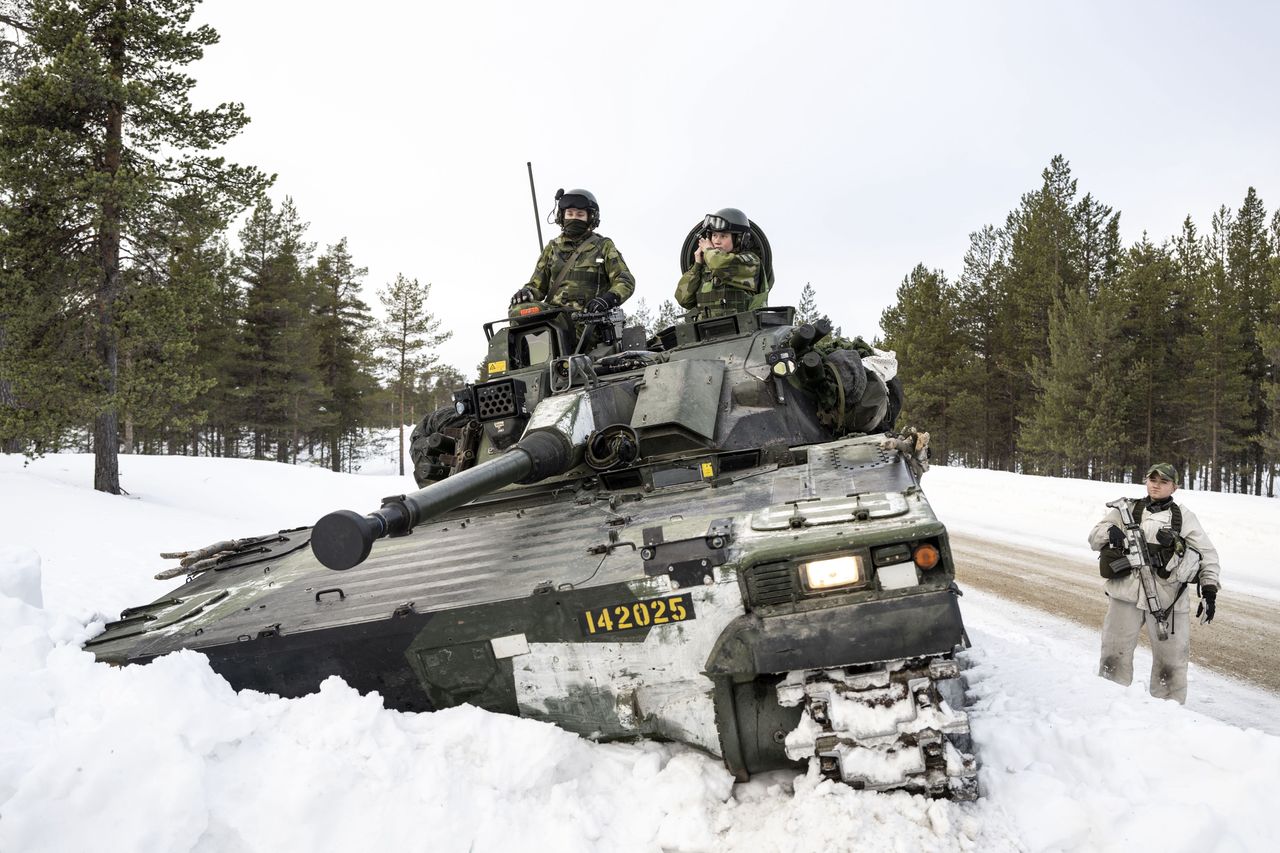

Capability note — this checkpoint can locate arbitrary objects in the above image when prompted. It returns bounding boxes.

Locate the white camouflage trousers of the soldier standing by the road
[1098,598,1192,704]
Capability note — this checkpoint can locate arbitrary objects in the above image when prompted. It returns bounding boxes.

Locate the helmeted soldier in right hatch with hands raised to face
[676,207,769,319]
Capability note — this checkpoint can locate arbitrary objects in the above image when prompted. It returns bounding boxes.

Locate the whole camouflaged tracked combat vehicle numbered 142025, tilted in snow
[87,224,977,799]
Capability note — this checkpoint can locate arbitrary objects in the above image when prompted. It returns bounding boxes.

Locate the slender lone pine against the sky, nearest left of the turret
[378,274,453,476]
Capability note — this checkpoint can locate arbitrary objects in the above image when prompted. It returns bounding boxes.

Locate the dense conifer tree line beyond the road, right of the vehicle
[881,156,1280,496]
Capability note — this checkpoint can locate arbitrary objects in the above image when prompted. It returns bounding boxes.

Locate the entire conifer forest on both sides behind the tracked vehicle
[0,0,1280,494]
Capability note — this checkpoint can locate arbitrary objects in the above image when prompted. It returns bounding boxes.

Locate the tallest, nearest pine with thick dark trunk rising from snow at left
[0,0,265,493]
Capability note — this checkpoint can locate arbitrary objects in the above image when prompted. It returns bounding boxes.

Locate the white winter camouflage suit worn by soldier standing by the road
[1089,494,1221,703]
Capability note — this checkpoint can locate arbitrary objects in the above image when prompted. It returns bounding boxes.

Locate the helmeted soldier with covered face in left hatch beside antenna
[511,190,636,313]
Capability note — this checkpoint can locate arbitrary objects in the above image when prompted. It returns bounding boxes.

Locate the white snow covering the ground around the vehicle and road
[0,445,1280,853]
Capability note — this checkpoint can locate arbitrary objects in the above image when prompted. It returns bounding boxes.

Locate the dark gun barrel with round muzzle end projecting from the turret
[311,430,573,571]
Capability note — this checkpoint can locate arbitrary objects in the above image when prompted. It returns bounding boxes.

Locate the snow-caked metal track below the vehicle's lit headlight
[777,658,978,800]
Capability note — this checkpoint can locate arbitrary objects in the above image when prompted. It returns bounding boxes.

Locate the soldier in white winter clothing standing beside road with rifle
[1089,462,1219,703]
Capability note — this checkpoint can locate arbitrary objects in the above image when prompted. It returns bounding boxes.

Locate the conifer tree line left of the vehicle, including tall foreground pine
[0,0,461,484]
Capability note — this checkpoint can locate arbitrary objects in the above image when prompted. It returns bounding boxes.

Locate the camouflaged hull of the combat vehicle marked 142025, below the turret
[87,435,972,793]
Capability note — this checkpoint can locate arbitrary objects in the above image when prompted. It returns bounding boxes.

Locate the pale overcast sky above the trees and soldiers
[193,0,1280,373]
